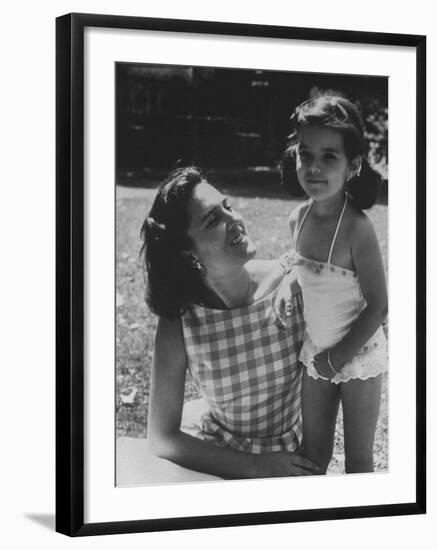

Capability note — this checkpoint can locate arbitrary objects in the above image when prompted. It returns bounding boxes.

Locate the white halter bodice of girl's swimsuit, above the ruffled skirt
[294,197,366,349]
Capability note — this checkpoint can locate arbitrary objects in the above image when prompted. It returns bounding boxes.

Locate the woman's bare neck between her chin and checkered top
[204,266,254,309]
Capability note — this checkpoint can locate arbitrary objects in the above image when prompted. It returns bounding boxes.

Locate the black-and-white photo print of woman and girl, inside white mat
[115,63,390,487]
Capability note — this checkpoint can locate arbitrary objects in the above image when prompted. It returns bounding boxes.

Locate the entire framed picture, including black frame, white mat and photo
[56,14,426,536]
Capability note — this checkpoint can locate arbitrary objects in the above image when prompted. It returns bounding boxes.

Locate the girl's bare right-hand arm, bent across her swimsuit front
[315,214,388,377]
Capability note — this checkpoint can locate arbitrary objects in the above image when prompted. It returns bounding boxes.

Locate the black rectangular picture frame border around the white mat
[56,13,426,536]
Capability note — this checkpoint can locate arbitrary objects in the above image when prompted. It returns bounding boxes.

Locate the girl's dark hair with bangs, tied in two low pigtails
[281,94,381,210]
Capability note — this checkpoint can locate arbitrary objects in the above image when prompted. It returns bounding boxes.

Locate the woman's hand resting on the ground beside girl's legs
[255,451,321,477]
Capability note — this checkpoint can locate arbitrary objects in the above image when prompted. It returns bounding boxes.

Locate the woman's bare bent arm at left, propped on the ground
[148,318,317,479]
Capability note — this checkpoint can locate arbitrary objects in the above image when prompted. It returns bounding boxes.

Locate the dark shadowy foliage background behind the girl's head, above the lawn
[116,63,388,179]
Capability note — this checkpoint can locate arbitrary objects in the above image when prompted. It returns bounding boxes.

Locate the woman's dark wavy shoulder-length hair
[140,166,205,319]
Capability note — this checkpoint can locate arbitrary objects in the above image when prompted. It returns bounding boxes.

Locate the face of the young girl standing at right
[296,126,352,200]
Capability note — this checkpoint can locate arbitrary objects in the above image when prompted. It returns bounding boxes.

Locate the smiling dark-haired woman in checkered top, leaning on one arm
[117,167,317,486]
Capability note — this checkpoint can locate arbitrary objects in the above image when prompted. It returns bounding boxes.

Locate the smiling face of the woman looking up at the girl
[188,182,256,271]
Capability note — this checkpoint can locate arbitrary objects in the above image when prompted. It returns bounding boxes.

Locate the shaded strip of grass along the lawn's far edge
[117,168,388,205]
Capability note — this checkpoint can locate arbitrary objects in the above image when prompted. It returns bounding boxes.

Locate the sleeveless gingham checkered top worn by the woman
[182,282,304,454]
